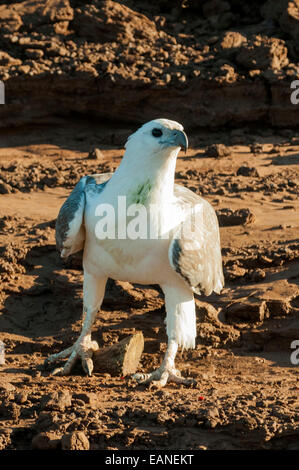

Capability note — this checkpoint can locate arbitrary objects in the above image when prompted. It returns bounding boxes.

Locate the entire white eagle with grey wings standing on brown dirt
[47,119,223,385]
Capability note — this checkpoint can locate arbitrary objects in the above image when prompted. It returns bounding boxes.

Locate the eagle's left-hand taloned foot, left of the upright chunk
[44,336,99,376]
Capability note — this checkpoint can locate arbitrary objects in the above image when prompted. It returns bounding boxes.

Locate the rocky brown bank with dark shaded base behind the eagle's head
[0,0,299,129]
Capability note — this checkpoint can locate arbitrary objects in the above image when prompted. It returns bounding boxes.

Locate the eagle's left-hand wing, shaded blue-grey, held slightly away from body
[56,173,112,258]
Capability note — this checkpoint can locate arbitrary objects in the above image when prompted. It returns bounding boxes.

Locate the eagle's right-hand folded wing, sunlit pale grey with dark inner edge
[168,185,224,295]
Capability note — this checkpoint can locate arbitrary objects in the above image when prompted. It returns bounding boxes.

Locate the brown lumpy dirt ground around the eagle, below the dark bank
[0,120,299,450]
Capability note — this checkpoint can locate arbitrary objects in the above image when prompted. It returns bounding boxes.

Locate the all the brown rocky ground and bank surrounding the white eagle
[0,0,299,450]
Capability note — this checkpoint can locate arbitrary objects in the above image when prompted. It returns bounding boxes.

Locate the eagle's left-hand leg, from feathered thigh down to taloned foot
[45,272,107,376]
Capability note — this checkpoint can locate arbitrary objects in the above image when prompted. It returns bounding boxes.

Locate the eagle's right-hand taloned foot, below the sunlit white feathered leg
[132,365,196,388]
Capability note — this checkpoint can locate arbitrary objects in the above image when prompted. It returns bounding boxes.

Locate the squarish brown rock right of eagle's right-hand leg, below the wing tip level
[224,298,267,323]
